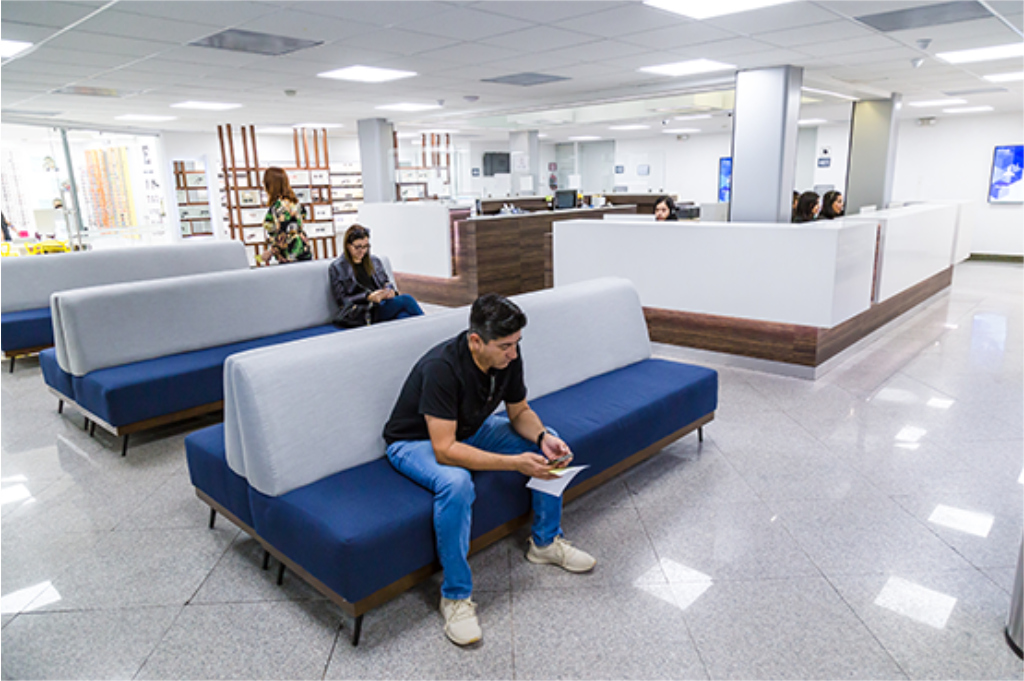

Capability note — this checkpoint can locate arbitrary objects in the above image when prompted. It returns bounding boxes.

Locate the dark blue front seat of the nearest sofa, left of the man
[249,458,440,603]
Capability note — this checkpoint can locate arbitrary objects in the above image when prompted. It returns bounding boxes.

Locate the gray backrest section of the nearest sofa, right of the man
[513,278,650,398]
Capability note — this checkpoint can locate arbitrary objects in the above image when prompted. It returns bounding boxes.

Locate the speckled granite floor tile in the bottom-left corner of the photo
[2,607,181,679]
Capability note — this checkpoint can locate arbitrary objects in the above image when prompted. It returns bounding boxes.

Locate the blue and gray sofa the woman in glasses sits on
[40,261,358,454]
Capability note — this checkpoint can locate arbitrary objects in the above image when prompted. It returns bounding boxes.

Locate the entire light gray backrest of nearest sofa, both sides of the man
[224,280,650,496]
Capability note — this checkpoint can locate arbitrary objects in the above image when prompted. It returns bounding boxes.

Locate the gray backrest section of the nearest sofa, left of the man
[224,308,469,497]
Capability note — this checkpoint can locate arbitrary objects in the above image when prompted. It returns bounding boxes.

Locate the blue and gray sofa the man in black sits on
[185,280,718,644]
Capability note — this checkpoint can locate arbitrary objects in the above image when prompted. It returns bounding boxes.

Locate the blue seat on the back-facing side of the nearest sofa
[185,423,253,527]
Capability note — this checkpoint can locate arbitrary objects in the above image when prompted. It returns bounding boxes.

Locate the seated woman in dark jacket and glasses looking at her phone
[330,224,423,327]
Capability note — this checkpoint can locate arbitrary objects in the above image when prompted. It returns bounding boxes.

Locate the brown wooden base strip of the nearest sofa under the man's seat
[196,412,715,645]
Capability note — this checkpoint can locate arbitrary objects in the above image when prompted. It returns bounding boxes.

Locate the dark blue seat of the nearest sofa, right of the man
[529,359,718,485]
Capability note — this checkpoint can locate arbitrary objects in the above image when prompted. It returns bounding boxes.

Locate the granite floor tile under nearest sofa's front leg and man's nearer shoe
[325,584,516,679]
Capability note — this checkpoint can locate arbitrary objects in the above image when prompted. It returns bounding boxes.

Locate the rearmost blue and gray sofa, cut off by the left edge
[0,242,249,371]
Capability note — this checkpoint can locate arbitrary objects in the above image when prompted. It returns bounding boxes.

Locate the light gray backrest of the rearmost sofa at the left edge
[0,241,249,312]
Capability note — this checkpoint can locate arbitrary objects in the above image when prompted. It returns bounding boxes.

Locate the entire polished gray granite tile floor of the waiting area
[2,262,1024,679]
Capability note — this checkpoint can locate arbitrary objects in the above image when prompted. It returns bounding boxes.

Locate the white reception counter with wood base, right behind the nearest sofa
[553,205,956,377]
